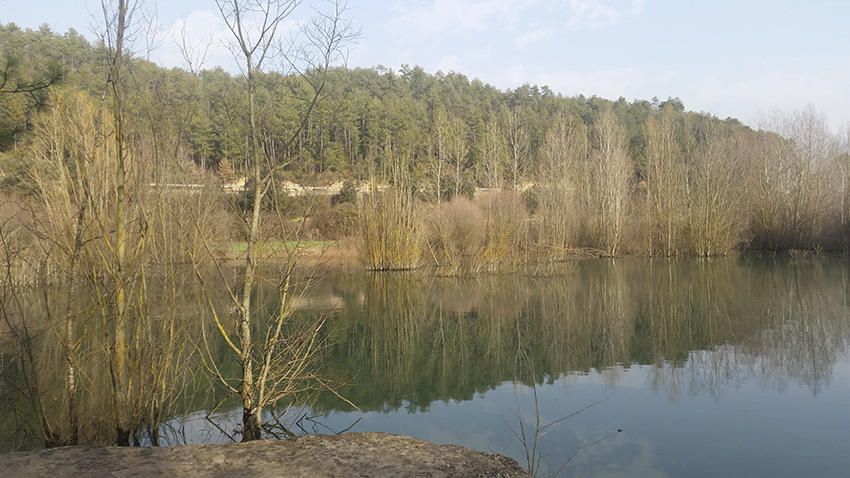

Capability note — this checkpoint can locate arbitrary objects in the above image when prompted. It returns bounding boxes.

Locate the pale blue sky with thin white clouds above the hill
[0,0,850,131]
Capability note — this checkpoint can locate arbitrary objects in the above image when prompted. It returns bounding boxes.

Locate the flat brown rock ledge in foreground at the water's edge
[0,433,527,478]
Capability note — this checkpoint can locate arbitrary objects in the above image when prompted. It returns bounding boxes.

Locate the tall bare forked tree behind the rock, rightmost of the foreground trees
[214,0,354,441]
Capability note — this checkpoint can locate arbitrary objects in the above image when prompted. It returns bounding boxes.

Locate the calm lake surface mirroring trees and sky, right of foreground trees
[1,257,850,477]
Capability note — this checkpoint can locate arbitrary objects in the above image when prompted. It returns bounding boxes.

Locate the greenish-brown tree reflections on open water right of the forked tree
[319,258,850,409]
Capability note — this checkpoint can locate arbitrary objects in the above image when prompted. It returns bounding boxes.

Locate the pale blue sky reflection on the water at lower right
[176,352,850,477]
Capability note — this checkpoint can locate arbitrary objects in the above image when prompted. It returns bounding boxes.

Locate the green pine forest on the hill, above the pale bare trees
[0,24,708,187]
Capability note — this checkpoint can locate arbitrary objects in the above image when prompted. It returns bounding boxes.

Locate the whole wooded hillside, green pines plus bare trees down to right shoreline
[0,24,848,255]
